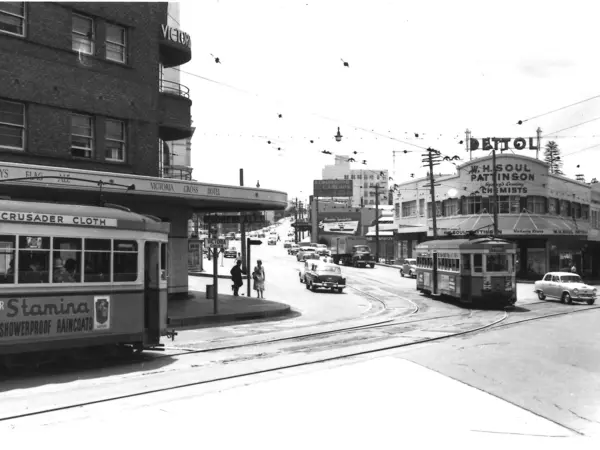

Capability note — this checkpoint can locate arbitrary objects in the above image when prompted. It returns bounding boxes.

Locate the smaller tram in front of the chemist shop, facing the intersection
[416,237,517,307]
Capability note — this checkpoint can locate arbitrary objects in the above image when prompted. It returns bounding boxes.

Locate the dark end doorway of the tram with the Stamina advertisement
[144,242,160,343]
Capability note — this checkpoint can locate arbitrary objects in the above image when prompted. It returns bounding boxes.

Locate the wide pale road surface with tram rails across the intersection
[0,218,600,442]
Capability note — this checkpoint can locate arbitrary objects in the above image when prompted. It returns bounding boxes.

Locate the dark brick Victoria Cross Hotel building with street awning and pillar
[0,2,287,294]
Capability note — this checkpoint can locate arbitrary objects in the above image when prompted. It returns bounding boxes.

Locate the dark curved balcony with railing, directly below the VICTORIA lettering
[158,80,194,141]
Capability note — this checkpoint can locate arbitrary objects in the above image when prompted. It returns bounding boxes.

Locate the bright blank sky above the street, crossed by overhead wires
[180,0,600,198]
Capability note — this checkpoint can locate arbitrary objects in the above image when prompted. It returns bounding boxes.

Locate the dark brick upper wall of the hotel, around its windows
[0,2,173,176]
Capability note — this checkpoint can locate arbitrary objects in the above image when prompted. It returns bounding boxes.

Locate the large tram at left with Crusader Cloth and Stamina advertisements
[0,200,174,358]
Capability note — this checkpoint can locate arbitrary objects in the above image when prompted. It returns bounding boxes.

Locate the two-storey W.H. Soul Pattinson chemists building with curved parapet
[394,153,600,279]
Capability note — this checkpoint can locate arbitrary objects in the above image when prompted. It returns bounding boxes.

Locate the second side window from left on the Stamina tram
[19,236,50,284]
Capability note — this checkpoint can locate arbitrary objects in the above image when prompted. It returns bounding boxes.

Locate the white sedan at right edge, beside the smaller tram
[534,272,596,305]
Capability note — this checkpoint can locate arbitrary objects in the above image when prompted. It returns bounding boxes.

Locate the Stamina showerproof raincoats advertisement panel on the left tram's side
[0,294,137,344]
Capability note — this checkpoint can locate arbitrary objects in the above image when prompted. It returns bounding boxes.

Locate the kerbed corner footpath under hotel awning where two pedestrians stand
[167,258,294,328]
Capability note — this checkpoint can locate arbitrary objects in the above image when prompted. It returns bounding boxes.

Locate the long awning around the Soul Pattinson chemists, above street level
[427,212,589,236]
